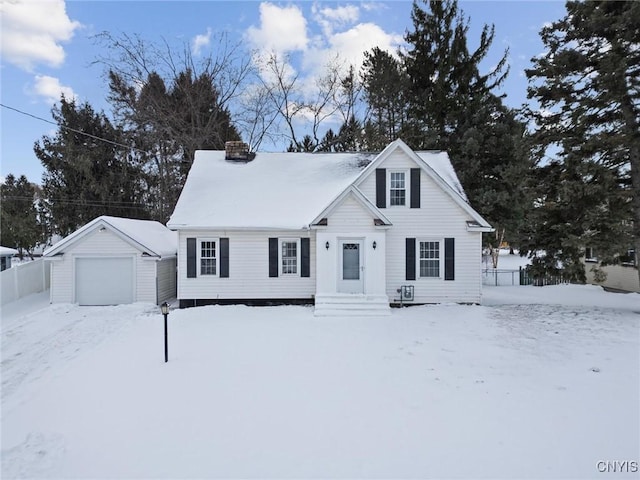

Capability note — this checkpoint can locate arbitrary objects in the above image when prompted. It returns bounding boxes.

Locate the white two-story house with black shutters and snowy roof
[167,140,492,315]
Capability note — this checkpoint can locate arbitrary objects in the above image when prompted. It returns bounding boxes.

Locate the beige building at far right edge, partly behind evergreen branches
[584,247,640,292]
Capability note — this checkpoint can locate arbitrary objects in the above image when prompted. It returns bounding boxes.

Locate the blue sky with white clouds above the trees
[0,0,565,183]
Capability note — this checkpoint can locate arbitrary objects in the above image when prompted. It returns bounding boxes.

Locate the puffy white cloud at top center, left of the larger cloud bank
[246,2,309,54]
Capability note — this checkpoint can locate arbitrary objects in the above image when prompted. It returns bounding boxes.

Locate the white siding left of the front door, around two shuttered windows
[178,230,316,300]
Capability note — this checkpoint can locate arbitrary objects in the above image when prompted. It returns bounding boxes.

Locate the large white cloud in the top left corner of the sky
[0,0,81,71]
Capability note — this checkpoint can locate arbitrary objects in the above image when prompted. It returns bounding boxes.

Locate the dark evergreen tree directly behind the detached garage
[34,96,146,235]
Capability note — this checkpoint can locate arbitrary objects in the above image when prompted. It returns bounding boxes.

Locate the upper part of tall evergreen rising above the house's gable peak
[401,0,508,150]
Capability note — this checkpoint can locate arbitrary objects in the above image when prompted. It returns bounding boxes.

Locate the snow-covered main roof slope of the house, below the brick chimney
[167,150,375,229]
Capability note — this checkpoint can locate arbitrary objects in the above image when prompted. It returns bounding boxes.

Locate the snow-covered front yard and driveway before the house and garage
[1,285,640,479]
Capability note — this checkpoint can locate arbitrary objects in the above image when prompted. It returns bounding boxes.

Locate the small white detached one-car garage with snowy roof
[43,216,177,305]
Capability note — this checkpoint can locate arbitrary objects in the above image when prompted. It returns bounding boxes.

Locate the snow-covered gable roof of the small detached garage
[44,215,178,257]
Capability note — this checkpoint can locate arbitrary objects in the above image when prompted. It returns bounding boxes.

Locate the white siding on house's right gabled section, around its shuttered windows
[359,150,482,303]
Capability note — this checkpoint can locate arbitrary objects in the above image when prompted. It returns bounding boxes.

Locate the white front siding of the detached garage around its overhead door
[51,229,156,303]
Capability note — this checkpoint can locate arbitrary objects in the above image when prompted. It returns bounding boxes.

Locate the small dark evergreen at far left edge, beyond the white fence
[0,174,44,258]
